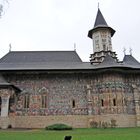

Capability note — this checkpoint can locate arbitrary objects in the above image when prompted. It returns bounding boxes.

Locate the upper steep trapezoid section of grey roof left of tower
[0,51,82,64]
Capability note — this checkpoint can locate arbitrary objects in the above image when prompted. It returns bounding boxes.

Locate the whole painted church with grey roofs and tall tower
[0,8,140,129]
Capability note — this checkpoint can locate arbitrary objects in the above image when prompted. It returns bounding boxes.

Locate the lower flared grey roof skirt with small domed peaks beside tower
[0,52,140,71]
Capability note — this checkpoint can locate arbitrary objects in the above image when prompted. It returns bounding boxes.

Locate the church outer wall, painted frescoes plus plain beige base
[0,73,140,128]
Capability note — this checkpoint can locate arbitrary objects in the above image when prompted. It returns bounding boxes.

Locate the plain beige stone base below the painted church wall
[0,114,137,128]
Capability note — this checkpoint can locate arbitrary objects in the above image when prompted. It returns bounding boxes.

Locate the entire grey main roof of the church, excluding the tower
[0,51,140,71]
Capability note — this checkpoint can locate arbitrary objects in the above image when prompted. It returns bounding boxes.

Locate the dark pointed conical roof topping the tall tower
[88,8,115,38]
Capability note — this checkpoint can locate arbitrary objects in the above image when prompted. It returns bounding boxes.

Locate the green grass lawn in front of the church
[0,128,140,140]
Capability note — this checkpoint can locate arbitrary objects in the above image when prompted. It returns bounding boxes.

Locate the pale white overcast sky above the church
[0,0,140,61]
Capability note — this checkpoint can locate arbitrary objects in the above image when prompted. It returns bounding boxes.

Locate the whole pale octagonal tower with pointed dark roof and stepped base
[88,8,117,64]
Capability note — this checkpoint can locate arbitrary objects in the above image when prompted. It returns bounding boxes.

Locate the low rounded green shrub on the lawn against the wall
[45,124,72,130]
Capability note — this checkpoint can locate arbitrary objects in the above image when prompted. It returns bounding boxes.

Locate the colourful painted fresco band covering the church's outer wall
[2,71,139,116]
